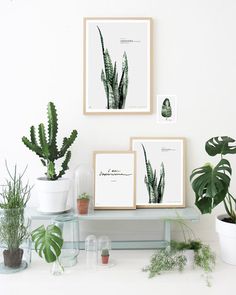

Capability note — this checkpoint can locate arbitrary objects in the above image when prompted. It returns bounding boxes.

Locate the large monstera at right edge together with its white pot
[190,136,236,265]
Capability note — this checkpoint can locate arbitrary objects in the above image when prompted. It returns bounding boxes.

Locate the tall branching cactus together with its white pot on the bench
[22,102,78,213]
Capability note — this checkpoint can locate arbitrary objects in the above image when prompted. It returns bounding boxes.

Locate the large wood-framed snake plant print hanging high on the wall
[84,17,152,114]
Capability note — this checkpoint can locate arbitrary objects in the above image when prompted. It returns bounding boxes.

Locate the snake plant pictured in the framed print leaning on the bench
[142,144,165,203]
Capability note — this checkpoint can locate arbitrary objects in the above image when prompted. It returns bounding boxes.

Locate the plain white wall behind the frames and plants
[0,0,236,243]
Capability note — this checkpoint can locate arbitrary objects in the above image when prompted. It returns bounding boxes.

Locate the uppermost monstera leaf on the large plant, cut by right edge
[205,136,236,156]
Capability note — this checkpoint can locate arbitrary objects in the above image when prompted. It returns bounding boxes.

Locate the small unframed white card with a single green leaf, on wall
[157,95,177,123]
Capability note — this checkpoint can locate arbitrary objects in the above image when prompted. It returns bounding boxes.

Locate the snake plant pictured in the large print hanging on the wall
[97,27,129,109]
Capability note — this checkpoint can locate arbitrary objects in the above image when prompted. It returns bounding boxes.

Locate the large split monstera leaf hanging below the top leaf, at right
[190,159,232,214]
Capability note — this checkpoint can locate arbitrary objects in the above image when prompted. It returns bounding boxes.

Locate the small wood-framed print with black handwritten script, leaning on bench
[94,151,136,209]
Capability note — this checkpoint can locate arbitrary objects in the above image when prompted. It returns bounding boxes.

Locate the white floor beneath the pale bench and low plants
[0,245,236,295]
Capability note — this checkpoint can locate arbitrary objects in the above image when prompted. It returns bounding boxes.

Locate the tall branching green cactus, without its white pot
[22,102,78,180]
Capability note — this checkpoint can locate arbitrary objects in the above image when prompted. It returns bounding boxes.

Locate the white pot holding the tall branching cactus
[36,178,70,213]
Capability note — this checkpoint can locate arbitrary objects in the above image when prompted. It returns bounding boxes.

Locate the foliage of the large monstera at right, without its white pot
[190,136,236,223]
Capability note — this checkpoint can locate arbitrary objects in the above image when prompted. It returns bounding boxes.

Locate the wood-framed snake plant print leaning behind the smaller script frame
[131,137,185,208]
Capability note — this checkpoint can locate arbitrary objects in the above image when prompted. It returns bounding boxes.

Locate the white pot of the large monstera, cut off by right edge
[216,215,236,265]
